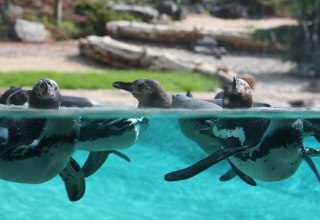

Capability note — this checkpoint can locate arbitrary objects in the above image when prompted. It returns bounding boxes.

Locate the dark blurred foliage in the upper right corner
[252,0,320,76]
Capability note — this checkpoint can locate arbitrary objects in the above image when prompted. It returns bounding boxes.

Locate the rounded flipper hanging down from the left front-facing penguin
[59,158,86,202]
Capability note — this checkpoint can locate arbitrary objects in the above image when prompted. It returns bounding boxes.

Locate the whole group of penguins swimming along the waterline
[0,78,320,201]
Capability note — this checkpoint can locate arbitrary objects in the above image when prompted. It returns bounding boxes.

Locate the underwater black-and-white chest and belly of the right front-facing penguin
[230,121,303,181]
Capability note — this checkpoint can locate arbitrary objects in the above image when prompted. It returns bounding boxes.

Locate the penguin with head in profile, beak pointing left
[113,79,255,185]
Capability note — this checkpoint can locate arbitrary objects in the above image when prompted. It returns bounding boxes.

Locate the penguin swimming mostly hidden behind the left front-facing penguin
[0,87,148,177]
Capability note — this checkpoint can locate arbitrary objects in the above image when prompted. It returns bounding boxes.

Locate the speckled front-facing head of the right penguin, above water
[222,77,252,108]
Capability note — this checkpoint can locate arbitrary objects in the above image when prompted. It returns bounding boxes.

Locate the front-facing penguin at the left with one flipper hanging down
[0,79,85,201]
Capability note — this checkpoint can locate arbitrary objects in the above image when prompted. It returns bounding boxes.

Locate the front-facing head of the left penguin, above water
[29,79,61,109]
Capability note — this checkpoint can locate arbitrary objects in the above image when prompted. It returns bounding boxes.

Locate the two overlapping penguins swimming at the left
[0,79,149,201]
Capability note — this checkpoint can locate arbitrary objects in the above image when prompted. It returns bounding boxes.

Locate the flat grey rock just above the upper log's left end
[112,5,159,22]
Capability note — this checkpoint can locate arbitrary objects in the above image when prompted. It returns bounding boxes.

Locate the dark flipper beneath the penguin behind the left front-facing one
[82,150,130,177]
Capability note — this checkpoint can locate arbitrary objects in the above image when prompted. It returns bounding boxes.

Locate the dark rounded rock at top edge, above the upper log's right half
[210,4,248,19]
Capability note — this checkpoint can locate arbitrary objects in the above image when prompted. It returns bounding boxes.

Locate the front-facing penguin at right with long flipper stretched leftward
[165,87,320,181]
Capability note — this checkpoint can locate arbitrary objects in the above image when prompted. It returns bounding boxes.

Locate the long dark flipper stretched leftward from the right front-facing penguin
[164,146,248,181]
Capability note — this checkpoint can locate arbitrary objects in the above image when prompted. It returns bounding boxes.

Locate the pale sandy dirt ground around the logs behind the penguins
[0,16,320,107]
